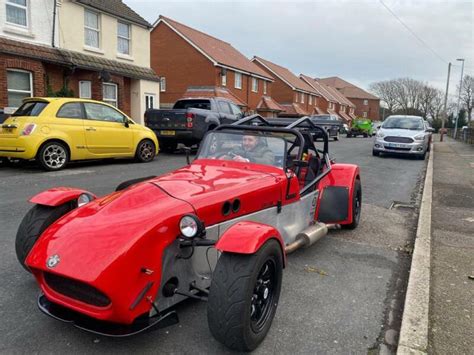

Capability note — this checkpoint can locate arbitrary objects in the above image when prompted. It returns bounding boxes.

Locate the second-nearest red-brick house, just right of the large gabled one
[252,56,321,117]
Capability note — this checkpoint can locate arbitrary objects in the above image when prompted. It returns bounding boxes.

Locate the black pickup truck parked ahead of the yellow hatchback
[145,97,243,152]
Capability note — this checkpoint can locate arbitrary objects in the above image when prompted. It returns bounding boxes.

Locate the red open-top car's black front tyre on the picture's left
[15,202,74,272]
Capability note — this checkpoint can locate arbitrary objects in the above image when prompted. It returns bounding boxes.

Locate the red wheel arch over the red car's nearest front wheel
[215,221,286,266]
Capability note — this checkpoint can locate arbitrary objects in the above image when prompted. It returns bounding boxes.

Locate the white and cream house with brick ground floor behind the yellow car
[0,0,159,122]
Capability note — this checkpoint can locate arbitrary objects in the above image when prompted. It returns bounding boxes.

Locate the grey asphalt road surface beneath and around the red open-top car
[0,138,426,354]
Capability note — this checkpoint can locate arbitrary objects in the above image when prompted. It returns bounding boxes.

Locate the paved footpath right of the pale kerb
[427,137,474,354]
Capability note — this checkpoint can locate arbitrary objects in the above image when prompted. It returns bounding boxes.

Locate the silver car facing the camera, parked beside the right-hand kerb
[372,116,433,159]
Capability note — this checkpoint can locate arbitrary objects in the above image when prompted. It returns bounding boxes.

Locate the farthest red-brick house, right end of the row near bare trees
[319,76,380,121]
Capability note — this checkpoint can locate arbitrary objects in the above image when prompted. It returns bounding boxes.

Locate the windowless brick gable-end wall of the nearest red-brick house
[150,23,215,105]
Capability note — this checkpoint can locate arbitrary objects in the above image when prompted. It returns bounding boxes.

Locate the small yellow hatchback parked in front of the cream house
[0,98,158,170]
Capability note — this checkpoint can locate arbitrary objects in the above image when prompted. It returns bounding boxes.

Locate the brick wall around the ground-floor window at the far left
[0,54,46,108]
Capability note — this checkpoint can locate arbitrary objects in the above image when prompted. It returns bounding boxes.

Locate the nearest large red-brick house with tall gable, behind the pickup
[150,16,278,115]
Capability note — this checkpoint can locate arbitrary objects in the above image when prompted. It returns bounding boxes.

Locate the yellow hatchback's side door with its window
[84,103,134,157]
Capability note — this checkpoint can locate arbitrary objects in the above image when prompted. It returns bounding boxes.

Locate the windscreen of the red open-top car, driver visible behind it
[197,131,286,168]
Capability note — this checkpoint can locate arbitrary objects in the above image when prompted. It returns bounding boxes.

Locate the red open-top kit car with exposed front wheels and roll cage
[16,115,362,351]
